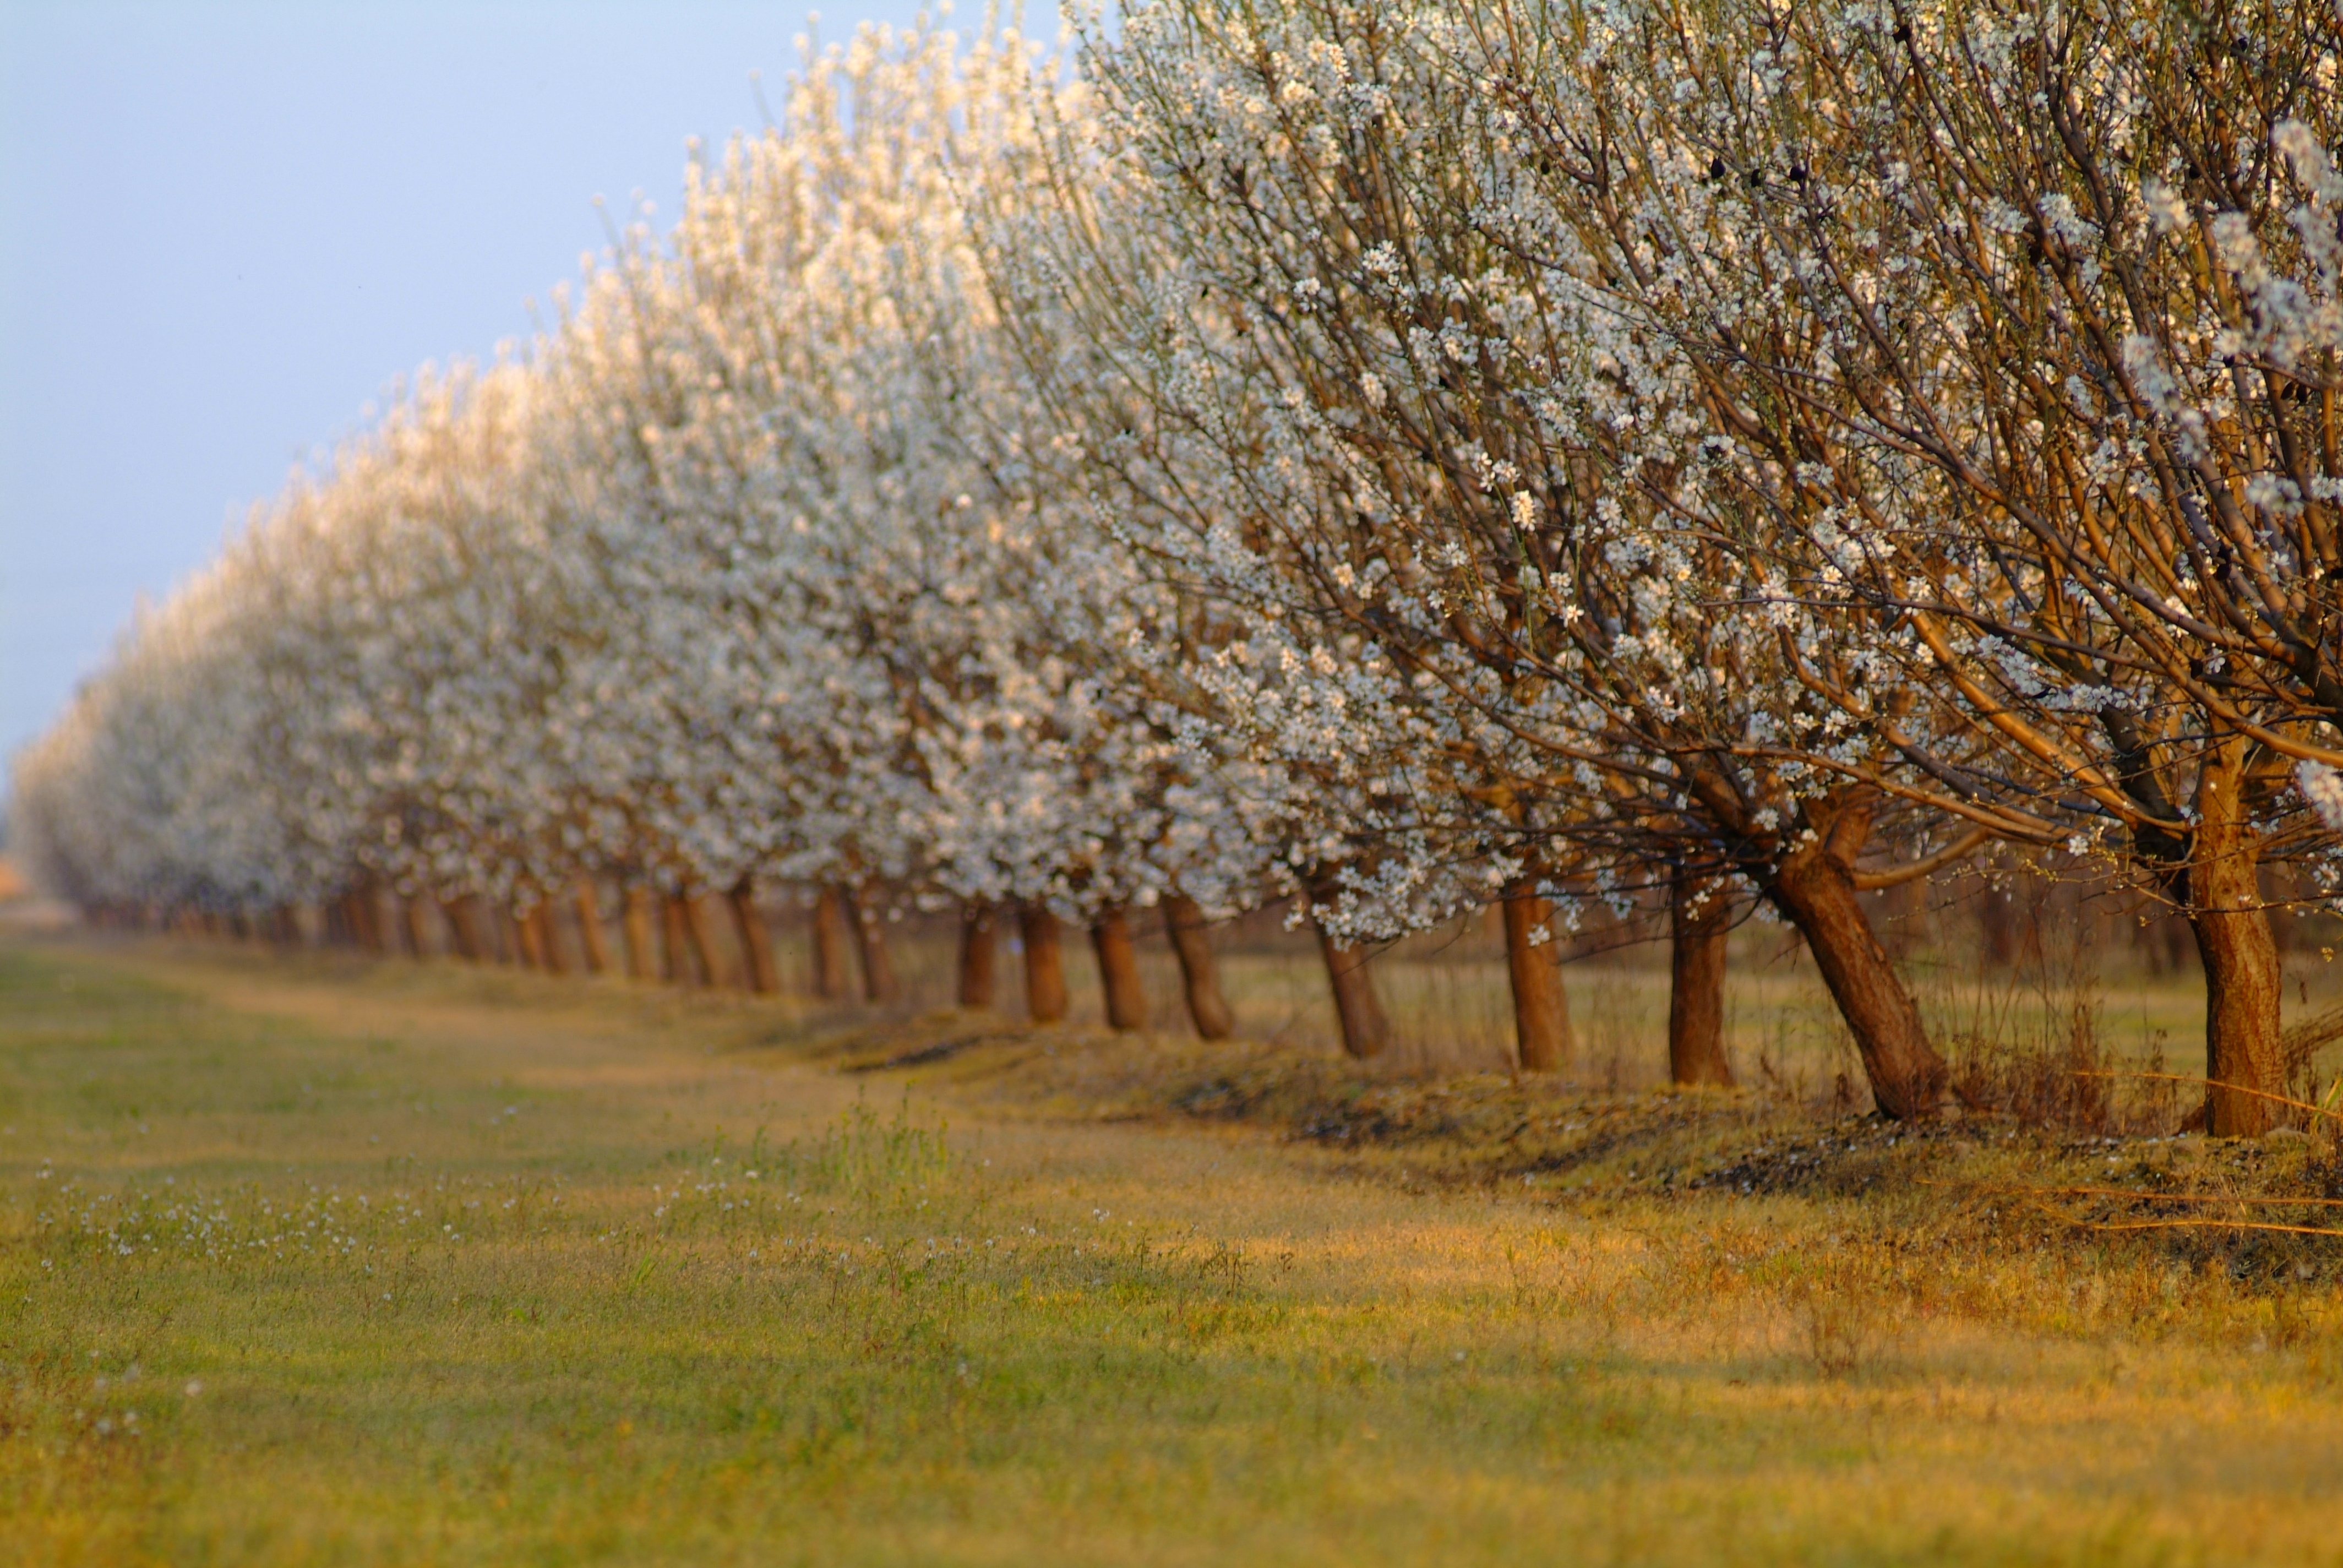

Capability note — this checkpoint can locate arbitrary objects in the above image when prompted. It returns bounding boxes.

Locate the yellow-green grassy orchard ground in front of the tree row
[0,933,2343,1563]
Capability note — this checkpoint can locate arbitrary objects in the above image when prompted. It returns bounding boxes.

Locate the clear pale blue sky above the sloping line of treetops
[0,0,1056,782]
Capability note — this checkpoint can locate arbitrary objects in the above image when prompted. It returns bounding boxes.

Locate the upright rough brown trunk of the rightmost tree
[2188,738,2287,1137]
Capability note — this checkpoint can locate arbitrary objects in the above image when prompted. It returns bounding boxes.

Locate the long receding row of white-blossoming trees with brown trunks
[14,0,2343,1132]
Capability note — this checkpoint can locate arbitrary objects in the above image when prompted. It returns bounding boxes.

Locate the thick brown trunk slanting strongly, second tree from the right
[1764,792,1952,1120]
